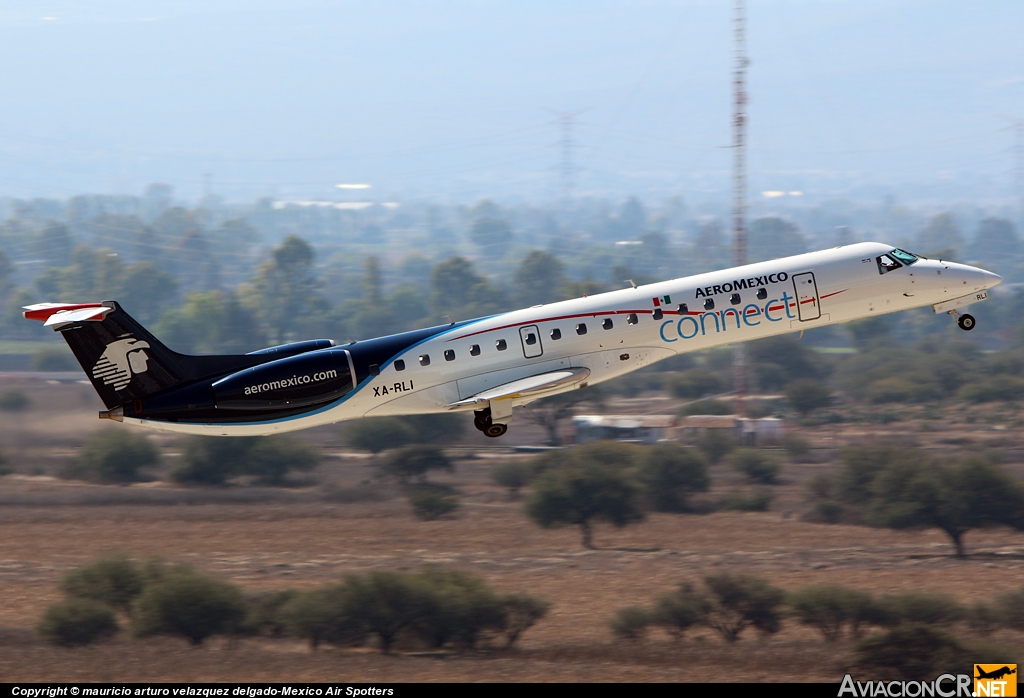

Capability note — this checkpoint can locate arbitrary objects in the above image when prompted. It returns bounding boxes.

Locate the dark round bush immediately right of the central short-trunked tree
[639,443,710,512]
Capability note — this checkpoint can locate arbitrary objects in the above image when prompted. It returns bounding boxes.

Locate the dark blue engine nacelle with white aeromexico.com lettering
[213,340,355,409]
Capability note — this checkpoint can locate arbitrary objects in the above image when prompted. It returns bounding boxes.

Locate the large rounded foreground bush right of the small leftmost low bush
[132,567,246,645]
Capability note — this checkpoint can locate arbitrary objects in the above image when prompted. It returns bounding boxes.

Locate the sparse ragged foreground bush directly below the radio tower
[705,574,785,642]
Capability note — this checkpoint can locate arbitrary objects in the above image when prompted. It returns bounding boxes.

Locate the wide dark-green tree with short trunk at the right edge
[868,459,1024,558]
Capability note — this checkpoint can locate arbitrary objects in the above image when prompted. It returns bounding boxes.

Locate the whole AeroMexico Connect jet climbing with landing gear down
[24,243,1002,437]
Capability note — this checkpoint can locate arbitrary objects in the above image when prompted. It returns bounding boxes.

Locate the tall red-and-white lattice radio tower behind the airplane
[732,0,750,417]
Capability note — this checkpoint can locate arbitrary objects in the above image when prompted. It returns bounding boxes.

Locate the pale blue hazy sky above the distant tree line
[0,0,1024,202]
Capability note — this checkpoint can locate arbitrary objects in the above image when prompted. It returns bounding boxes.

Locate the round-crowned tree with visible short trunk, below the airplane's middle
[526,463,643,550]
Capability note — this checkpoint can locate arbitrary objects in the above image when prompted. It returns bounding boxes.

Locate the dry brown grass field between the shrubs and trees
[0,374,1024,682]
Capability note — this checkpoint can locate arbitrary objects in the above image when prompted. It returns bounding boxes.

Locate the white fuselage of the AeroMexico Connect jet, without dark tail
[125,243,1001,435]
